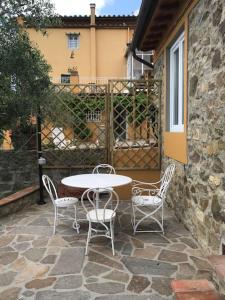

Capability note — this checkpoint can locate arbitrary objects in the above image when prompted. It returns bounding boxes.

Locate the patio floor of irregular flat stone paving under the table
[0,201,212,300]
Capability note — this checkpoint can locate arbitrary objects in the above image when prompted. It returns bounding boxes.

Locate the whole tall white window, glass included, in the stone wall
[169,33,184,132]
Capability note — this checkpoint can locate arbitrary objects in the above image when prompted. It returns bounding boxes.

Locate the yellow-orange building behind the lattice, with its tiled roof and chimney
[28,4,136,83]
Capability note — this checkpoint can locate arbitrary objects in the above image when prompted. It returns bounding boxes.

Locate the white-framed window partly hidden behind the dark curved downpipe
[127,51,153,79]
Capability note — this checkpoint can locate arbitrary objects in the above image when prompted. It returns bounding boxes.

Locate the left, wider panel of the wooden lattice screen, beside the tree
[42,85,108,168]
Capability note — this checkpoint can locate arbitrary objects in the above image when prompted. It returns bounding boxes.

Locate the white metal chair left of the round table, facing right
[42,175,80,234]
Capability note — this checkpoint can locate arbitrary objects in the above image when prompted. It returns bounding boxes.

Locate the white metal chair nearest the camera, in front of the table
[81,188,119,255]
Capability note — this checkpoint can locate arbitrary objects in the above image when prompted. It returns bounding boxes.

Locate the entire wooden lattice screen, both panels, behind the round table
[42,80,160,169]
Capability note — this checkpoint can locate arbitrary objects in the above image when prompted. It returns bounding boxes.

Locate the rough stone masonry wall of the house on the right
[155,0,225,254]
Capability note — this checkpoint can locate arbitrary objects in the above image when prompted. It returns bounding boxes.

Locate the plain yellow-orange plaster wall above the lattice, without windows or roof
[28,28,133,83]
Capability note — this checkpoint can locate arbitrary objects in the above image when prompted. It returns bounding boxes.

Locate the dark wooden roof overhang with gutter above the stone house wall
[130,0,191,51]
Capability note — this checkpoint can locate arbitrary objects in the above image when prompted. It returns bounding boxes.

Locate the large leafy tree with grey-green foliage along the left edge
[0,0,55,148]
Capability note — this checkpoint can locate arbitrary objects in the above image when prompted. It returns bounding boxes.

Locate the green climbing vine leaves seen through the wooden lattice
[45,89,148,140]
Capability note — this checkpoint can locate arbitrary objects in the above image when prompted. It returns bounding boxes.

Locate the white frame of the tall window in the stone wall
[169,32,184,132]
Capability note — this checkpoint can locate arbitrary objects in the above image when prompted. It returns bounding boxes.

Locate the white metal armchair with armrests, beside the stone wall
[132,164,175,234]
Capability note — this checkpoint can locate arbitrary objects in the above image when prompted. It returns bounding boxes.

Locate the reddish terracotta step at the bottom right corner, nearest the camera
[171,279,222,300]
